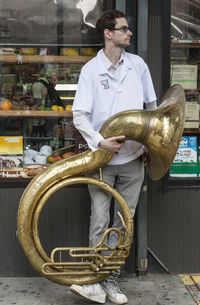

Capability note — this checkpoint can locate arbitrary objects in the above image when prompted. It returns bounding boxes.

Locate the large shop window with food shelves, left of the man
[0,0,115,181]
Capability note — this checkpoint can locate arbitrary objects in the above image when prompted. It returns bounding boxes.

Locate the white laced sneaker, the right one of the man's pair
[101,279,128,304]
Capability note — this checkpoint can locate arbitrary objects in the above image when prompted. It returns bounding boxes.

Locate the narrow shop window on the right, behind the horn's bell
[170,0,200,186]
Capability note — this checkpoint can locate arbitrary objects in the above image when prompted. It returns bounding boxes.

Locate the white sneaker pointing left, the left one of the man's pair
[69,283,106,304]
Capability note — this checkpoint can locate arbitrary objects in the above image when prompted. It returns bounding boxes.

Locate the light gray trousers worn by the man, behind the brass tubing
[88,159,144,246]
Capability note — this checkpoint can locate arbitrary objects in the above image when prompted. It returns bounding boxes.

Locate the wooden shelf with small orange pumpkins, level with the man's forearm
[0,110,73,118]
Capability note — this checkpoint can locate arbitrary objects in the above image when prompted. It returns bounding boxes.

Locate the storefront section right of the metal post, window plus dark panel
[148,0,200,273]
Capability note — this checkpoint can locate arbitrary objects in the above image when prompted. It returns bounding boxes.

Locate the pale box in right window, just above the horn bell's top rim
[171,65,198,89]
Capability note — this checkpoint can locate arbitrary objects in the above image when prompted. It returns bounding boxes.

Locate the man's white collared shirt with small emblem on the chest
[72,50,156,164]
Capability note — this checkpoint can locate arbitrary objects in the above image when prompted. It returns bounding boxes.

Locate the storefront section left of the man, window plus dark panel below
[0,0,141,276]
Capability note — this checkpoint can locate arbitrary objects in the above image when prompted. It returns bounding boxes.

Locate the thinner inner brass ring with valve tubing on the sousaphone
[31,177,133,285]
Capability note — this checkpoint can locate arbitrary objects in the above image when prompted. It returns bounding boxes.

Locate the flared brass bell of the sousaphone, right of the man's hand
[101,85,185,180]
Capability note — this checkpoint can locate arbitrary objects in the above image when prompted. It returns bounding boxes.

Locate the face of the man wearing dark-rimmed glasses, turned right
[110,18,132,48]
